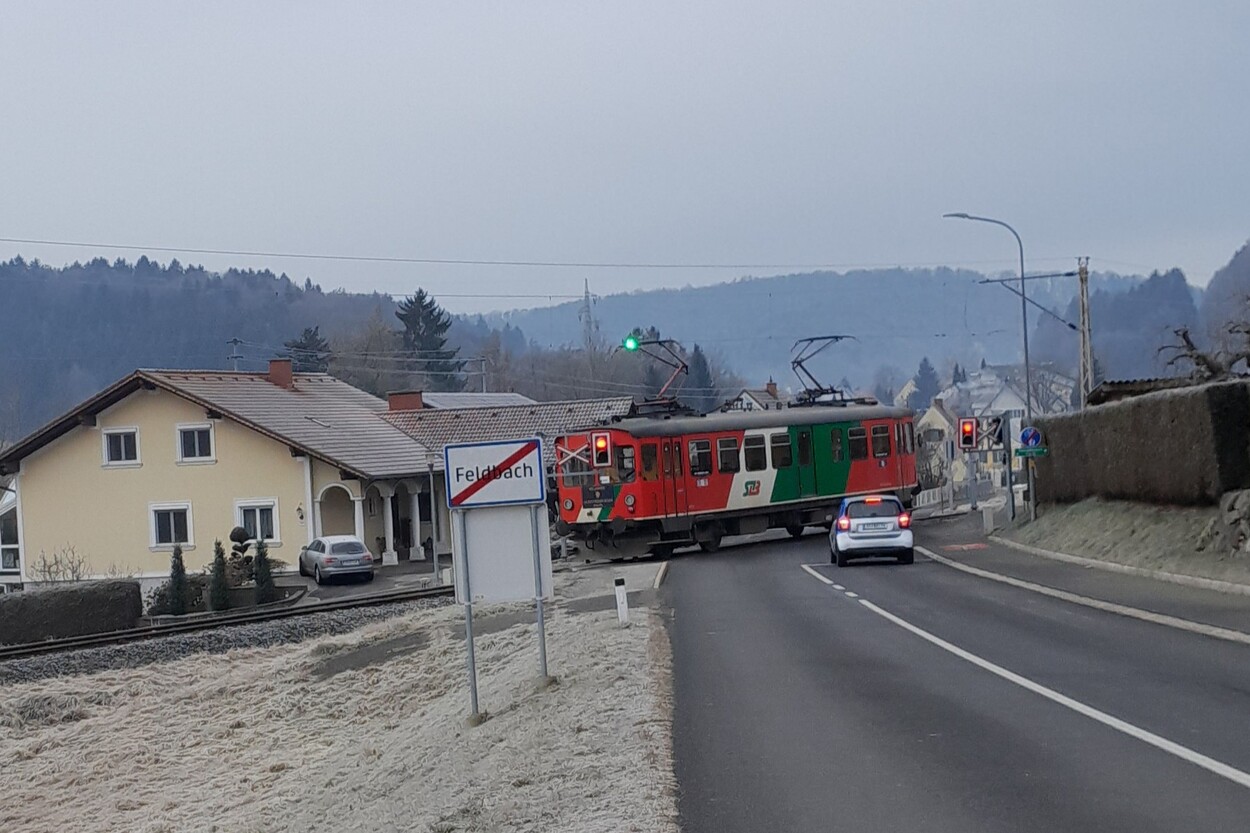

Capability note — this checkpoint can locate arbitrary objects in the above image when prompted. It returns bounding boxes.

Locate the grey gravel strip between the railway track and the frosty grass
[0,598,451,685]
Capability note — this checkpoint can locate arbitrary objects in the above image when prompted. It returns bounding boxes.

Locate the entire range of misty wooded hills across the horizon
[0,248,1230,442]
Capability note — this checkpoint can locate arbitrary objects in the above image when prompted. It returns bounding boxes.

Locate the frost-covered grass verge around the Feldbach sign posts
[0,592,676,833]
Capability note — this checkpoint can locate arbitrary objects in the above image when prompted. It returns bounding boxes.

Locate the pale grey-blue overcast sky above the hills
[0,0,1250,310]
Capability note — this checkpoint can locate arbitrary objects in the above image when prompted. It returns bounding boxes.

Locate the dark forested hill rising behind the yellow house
[0,258,394,440]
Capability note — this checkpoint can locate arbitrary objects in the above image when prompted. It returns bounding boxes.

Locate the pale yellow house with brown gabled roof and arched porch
[0,359,450,584]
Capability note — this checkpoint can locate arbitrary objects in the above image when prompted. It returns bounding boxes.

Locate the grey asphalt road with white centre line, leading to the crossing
[663,523,1250,833]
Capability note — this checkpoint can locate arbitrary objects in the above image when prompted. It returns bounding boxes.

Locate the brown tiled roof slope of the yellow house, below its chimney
[146,370,426,478]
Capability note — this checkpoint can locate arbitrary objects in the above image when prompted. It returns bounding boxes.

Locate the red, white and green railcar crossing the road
[555,403,916,558]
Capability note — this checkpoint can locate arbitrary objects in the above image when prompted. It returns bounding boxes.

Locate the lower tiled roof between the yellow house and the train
[383,396,634,468]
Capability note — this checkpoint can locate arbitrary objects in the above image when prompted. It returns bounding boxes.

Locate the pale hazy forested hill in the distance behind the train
[488,264,1160,388]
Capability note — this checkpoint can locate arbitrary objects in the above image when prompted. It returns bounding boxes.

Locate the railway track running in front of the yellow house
[0,587,455,662]
